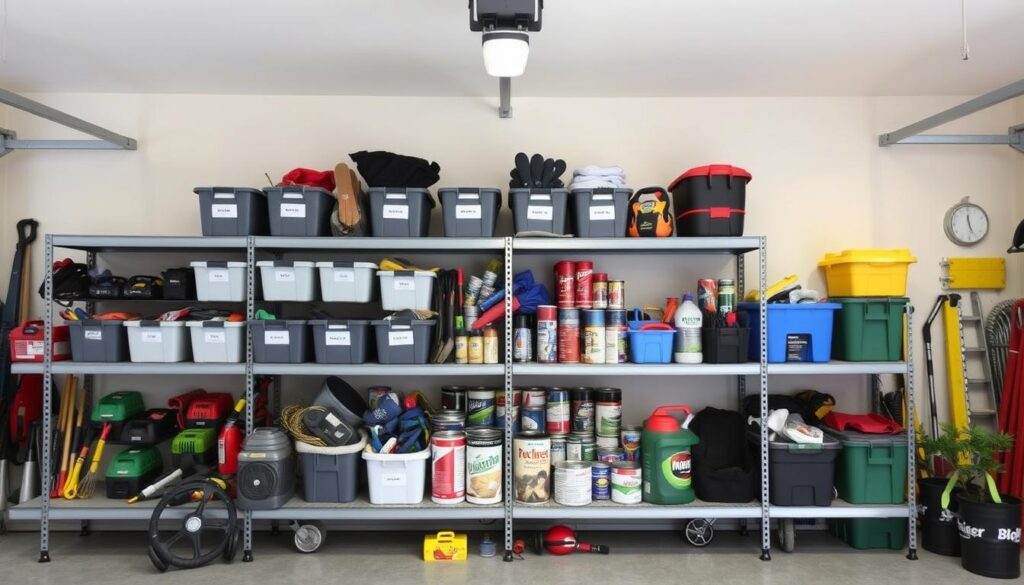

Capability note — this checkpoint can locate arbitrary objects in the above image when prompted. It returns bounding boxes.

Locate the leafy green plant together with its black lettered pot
[932,424,1021,579]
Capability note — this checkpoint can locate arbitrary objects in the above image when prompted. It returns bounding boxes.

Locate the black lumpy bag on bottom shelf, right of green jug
[690,407,760,503]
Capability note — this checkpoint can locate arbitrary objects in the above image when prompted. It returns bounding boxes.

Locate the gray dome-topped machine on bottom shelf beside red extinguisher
[236,426,295,510]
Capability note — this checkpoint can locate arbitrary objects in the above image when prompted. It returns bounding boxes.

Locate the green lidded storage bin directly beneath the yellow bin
[828,297,910,362]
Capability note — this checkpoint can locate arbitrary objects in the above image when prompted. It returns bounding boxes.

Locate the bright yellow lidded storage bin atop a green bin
[818,248,918,296]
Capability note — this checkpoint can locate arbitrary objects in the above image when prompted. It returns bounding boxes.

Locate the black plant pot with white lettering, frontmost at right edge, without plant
[956,494,1021,579]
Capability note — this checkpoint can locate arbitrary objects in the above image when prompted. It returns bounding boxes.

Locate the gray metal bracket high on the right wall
[879,79,1024,153]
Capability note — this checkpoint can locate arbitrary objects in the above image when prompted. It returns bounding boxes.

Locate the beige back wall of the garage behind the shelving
[0,94,1024,422]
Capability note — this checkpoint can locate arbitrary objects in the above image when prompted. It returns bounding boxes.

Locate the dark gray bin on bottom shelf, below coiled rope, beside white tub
[295,430,367,503]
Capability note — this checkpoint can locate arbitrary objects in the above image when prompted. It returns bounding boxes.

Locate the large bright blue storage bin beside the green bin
[737,302,842,364]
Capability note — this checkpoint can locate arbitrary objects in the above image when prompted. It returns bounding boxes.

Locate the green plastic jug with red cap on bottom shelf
[640,405,700,504]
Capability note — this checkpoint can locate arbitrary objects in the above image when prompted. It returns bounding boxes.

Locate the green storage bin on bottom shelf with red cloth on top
[826,429,907,504]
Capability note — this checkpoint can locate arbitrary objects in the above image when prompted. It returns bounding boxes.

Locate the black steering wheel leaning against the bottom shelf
[148,479,239,572]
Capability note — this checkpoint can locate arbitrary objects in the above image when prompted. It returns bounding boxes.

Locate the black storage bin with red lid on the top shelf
[669,165,752,237]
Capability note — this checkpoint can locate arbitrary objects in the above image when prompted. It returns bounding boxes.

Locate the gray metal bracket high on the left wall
[0,89,138,157]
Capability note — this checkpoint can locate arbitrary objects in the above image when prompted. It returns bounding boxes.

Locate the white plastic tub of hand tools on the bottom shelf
[362,448,430,505]
